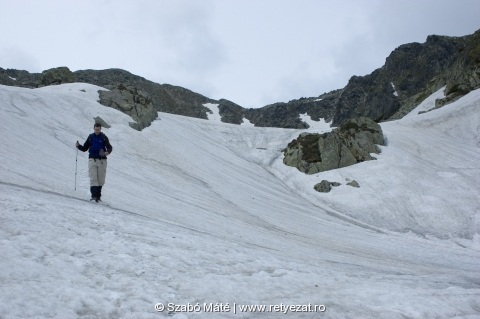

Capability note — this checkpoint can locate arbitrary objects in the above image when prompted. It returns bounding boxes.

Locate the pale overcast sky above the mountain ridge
[0,0,480,107]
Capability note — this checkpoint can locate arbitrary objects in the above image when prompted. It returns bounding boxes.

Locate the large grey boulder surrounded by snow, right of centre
[283,117,385,174]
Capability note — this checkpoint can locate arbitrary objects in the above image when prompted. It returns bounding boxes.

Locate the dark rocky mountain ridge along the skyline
[0,30,480,129]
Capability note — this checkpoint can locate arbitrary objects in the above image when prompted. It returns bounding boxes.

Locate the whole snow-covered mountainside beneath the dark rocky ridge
[0,83,480,319]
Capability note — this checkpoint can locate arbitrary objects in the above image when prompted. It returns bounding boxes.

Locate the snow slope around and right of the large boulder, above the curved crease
[275,89,480,244]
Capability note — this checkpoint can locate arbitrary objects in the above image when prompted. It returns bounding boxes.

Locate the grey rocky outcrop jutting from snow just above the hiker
[98,84,158,131]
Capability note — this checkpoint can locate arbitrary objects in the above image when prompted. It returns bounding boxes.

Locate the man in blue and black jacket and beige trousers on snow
[76,123,112,202]
